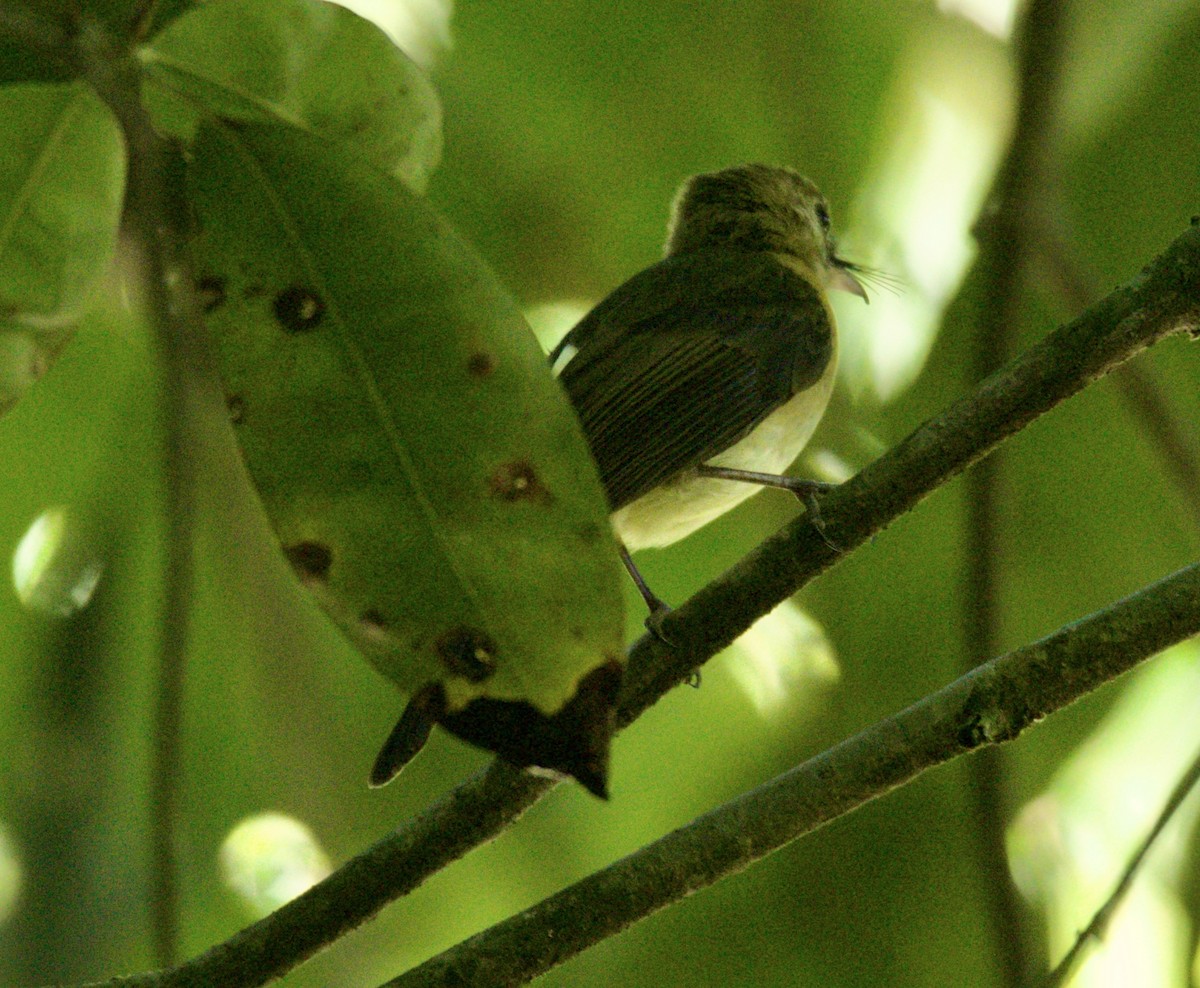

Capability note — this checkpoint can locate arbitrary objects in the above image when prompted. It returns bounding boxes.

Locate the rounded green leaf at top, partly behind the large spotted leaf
[140,0,442,192]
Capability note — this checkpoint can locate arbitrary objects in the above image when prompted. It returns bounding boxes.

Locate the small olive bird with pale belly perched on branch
[548,163,869,624]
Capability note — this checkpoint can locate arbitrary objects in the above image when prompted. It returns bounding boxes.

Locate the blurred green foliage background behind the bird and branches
[0,0,1200,988]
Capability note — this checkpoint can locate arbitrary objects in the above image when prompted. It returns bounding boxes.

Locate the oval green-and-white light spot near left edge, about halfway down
[12,507,104,617]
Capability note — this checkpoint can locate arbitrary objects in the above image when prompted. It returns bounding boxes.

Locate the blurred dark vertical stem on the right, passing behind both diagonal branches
[961,0,1064,988]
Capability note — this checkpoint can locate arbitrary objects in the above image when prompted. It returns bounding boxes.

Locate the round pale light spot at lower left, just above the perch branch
[220,813,330,916]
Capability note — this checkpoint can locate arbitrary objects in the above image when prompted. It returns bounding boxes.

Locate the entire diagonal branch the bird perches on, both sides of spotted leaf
[72,224,1200,988]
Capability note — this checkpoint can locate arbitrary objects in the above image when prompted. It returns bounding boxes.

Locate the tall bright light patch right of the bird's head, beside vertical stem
[832,21,1012,402]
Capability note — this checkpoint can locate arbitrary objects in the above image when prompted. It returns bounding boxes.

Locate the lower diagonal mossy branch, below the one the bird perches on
[382,563,1200,988]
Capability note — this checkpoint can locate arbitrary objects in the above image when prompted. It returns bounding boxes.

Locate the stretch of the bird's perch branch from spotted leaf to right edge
[618,222,1200,710]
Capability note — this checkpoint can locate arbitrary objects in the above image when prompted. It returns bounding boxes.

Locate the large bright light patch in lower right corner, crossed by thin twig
[1007,642,1200,986]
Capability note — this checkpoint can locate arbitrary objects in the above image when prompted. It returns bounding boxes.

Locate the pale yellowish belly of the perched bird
[612,360,835,552]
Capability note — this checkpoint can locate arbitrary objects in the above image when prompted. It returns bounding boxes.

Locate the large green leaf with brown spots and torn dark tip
[191,125,623,785]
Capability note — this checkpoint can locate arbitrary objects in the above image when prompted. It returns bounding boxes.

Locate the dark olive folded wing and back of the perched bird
[551,251,833,510]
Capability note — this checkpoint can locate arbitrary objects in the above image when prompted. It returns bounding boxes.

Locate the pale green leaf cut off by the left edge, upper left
[0,83,125,414]
